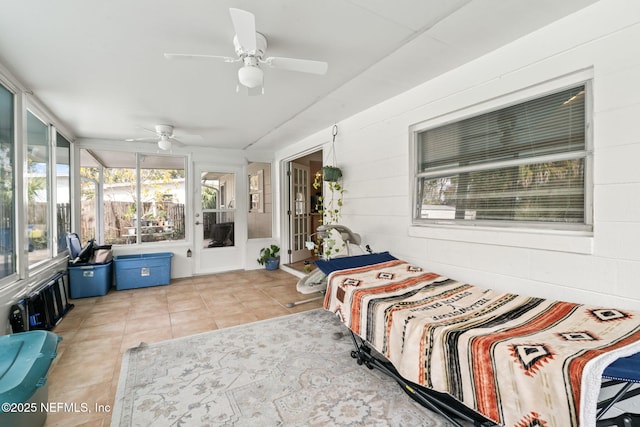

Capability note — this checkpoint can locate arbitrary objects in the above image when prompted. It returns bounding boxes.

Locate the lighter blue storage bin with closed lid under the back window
[114,252,173,291]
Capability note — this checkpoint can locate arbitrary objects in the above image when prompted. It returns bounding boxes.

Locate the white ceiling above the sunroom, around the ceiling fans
[0,0,596,150]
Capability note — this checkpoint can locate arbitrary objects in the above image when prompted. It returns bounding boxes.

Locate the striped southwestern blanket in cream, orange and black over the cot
[324,260,640,427]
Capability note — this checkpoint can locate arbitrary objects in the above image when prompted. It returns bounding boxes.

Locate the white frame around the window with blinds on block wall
[409,79,593,234]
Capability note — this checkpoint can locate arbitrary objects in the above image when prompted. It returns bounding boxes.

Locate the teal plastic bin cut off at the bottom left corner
[0,330,61,427]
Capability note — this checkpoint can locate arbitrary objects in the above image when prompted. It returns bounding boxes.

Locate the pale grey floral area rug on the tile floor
[111,309,456,427]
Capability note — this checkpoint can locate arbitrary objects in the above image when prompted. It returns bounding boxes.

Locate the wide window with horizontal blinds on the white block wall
[414,85,591,229]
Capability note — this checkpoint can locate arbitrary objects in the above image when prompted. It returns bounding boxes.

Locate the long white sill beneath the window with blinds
[409,225,593,254]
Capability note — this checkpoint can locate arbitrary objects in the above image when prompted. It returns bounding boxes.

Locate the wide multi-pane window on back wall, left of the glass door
[80,150,186,245]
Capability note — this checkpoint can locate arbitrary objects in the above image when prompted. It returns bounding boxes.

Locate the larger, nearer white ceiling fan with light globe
[164,8,328,95]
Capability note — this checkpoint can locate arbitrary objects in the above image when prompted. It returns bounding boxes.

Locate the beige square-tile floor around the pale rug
[45,270,322,427]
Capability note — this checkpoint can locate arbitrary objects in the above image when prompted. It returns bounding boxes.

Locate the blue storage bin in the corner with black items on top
[67,261,113,298]
